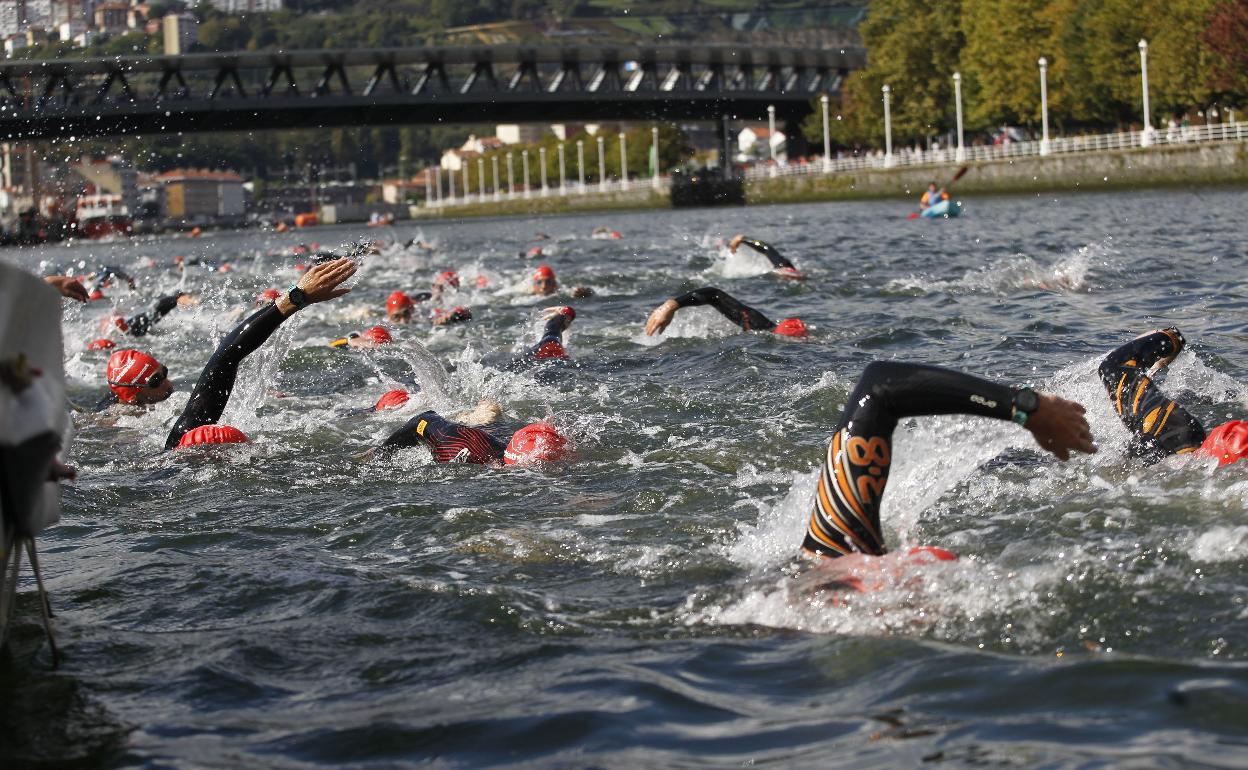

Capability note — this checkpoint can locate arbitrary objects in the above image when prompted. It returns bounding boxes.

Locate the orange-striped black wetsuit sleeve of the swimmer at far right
[1098,328,1206,461]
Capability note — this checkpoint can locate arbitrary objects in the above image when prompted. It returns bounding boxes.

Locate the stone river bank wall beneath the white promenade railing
[412,141,1248,218]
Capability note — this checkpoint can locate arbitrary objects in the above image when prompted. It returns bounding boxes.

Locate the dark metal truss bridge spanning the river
[0,45,866,141]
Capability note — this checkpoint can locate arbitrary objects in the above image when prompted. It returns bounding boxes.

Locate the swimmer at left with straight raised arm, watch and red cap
[165,257,358,449]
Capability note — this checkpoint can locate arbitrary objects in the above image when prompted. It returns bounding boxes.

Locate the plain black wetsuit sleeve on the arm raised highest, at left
[165,305,286,449]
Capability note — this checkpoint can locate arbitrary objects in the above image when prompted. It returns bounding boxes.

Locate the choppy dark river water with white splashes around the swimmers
[0,190,1248,768]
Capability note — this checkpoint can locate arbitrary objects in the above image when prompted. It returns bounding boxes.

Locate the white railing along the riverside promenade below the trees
[745,121,1248,180]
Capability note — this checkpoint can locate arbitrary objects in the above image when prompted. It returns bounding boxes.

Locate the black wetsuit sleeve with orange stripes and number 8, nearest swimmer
[801,361,1015,557]
